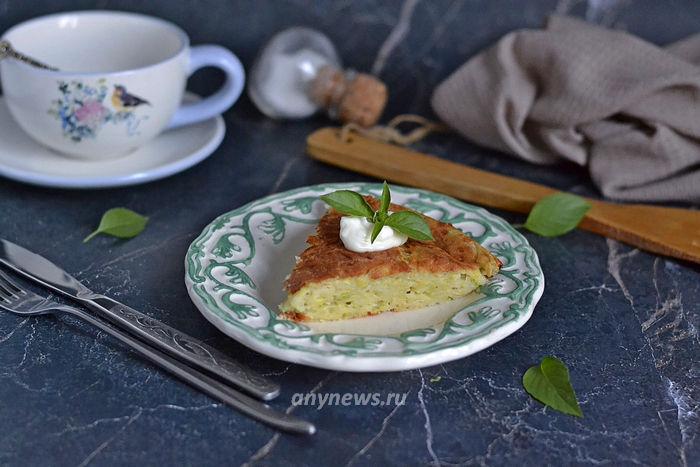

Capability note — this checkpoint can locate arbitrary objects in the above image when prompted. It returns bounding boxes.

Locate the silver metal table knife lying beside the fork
[0,238,280,400]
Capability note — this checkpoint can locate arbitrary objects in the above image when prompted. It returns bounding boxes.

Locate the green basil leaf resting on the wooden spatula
[525,193,591,237]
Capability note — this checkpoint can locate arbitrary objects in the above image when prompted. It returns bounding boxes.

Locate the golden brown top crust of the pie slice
[286,196,501,294]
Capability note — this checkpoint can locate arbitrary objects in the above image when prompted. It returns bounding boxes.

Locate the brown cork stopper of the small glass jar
[309,66,387,127]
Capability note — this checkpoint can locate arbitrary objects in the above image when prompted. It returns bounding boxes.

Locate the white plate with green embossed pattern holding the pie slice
[185,183,544,371]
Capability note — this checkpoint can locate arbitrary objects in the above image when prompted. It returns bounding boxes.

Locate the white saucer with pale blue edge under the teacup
[0,93,226,188]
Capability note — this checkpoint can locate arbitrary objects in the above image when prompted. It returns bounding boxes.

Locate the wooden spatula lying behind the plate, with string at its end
[307,128,700,263]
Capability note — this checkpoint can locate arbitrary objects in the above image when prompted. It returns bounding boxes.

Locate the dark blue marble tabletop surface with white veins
[0,0,700,466]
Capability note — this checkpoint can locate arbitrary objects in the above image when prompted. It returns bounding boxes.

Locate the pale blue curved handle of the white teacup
[166,45,245,129]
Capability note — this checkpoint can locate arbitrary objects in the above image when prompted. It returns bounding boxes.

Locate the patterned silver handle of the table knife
[81,294,280,400]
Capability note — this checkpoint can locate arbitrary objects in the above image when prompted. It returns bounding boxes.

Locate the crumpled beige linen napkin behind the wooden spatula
[432,16,700,202]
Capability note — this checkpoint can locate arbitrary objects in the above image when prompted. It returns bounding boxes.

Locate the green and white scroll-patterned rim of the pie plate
[186,183,544,358]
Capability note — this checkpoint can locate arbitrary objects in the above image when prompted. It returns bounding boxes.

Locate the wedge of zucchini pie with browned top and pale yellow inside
[280,197,501,321]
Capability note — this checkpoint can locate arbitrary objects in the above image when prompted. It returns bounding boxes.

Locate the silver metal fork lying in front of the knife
[0,271,316,435]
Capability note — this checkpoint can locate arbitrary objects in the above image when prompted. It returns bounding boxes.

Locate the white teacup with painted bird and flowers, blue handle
[0,11,245,159]
